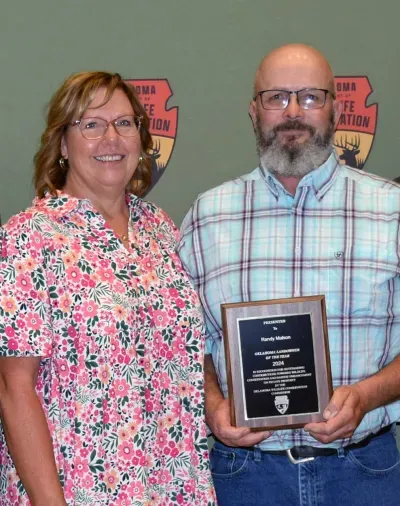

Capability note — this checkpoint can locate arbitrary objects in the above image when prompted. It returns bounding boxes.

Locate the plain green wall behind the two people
[0,0,400,224]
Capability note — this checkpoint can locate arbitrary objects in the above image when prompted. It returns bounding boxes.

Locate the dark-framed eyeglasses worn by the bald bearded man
[253,88,335,111]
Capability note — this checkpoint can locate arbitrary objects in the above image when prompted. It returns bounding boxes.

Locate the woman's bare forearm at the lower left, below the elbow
[0,388,66,506]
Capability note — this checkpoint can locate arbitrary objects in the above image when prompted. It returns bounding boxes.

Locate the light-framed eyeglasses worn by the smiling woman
[71,115,143,140]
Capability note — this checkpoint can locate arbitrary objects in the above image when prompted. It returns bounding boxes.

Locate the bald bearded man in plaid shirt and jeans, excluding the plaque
[179,44,400,506]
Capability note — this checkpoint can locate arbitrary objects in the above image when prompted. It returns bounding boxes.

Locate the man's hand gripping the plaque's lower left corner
[207,399,272,446]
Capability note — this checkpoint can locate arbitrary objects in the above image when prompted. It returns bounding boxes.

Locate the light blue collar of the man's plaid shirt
[260,149,340,200]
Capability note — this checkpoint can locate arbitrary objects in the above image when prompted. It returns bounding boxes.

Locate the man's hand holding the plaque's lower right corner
[304,384,368,443]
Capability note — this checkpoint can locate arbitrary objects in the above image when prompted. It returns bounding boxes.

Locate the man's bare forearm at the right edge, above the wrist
[357,356,400,413]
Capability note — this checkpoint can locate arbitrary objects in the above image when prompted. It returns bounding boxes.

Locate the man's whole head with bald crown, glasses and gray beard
[249,44,341,185]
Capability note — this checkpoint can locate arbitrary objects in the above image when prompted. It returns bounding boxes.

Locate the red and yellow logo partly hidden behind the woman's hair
[126,79,178,191]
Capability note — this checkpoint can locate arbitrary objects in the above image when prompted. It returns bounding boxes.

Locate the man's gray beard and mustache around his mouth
[254,115,335,179]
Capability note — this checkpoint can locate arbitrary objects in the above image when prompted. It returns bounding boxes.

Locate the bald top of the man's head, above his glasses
[254,44,335,96]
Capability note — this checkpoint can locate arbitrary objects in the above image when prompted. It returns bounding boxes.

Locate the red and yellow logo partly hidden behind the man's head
[334,76,378,169]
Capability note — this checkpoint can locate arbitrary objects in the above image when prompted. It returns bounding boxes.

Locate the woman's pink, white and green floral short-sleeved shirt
[0,192,216,506]
